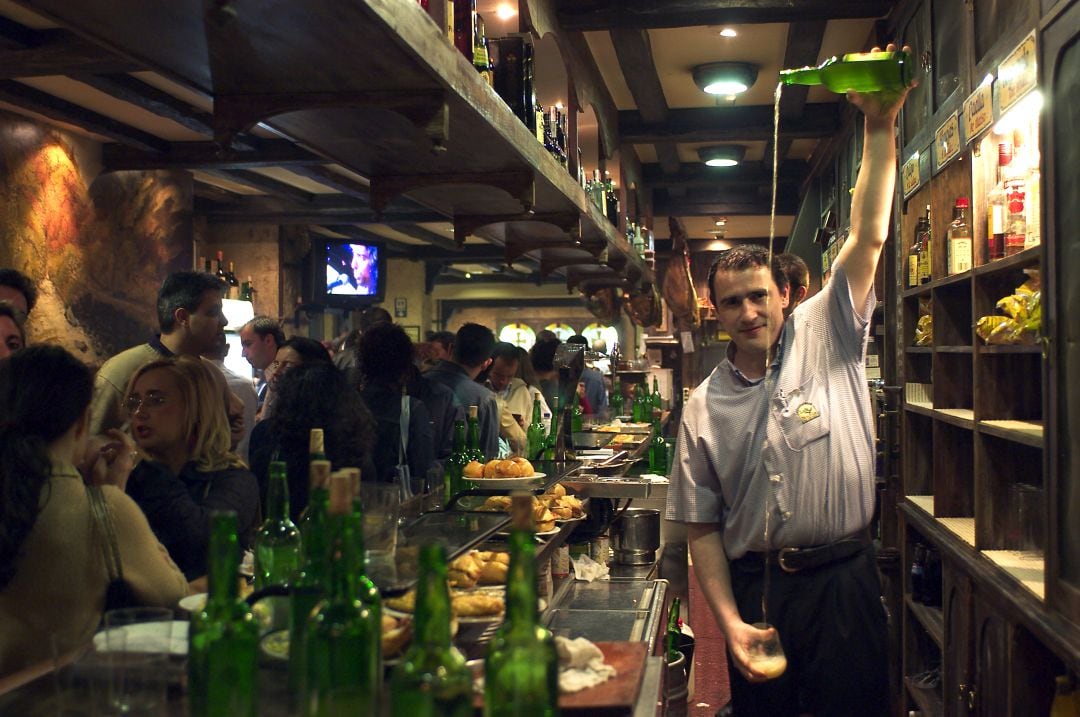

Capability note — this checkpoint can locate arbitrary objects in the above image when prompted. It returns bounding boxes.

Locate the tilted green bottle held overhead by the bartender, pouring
[780,51,915,94]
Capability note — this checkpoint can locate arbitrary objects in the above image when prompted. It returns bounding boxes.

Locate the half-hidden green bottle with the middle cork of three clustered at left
[288,460,330,704]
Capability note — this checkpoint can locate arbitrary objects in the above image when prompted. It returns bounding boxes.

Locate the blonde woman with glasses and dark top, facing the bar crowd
[125,356,260,580]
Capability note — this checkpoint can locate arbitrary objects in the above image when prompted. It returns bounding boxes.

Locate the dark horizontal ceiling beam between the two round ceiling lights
[619,103,840,145]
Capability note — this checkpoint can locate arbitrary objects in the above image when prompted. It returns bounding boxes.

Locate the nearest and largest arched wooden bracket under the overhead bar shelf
[214,90,450,151]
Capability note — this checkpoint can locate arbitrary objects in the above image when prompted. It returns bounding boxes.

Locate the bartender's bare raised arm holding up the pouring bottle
[837,44,915,307]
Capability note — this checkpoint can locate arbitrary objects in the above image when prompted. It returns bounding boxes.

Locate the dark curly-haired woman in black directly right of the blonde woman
[251,361,375,520]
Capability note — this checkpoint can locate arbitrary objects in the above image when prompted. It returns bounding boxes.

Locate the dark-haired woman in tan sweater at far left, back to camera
[0,346,188,675]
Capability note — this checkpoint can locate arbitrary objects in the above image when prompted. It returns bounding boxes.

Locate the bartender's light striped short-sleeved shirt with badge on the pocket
[666,267,875,559]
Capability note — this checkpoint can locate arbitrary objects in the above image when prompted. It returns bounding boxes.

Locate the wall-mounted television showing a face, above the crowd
[313,239,387,309]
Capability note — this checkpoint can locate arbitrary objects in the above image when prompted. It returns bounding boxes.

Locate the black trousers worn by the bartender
[728,545,889,717]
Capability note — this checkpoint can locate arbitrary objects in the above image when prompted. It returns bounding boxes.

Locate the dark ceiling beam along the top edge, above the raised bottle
[557,0,894,31]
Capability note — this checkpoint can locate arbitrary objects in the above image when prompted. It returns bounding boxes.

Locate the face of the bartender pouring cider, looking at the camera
[713,267,787,365]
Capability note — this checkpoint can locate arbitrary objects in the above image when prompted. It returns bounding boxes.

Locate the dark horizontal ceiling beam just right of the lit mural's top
[102,139,327,171]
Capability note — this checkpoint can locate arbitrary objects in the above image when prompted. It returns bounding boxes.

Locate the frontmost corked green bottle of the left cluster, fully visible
[304,474,382,717]
